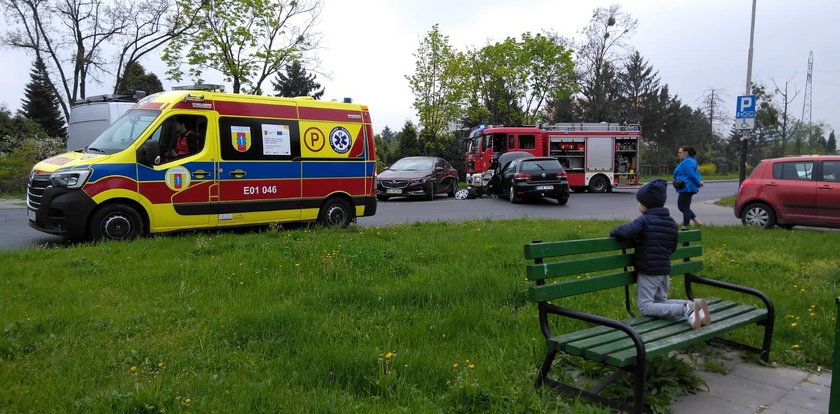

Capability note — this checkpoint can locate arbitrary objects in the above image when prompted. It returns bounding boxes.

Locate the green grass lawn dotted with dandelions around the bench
[0,219,840,413]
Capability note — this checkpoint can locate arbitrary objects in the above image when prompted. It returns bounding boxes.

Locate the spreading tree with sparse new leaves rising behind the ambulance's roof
[163,0,322,94]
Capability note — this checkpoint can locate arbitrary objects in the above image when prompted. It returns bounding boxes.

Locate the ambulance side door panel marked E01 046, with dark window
[217,116,301,225]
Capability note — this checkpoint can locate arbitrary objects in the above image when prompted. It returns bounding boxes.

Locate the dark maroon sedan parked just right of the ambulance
[376,157,458,201]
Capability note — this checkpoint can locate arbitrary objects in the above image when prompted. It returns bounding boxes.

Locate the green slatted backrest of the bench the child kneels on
[525,230,703,302]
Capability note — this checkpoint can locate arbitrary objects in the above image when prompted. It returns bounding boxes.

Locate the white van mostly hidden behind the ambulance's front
[67,91,146,151]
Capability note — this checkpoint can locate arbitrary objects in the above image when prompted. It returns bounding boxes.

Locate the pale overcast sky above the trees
[0,0,840,139]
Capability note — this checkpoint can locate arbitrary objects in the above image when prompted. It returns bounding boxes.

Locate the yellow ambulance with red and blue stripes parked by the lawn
[26,90,376,240]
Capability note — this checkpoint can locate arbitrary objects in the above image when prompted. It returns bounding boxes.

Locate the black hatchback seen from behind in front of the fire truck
[496,157,569,206]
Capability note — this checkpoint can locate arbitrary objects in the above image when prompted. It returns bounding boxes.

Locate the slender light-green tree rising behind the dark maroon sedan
[406,25,466,148]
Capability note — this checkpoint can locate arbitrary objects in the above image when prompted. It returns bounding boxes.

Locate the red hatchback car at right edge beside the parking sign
[735,155,840,229]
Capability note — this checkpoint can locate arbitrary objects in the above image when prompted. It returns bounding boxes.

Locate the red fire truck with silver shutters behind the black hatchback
[465,123,641,193]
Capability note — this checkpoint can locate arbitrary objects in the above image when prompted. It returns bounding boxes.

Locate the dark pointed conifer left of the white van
[20,57,67,138]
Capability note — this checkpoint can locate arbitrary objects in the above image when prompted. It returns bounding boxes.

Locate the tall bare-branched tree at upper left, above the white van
[0,0,196,119]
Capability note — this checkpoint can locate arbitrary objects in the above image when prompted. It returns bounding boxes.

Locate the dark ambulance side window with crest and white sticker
[219,117,300,161]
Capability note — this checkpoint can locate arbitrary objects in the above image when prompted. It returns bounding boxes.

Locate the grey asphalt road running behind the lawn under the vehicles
[0,181,740,250]
